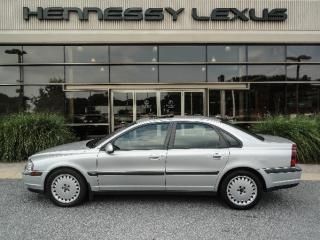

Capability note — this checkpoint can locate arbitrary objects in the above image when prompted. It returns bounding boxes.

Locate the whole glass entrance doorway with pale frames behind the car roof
[111,90,205,131]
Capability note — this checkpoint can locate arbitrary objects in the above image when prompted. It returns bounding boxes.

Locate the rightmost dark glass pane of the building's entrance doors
[184,92,203,115]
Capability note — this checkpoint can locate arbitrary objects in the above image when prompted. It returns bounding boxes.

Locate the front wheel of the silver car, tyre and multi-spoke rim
[45,168,88,207]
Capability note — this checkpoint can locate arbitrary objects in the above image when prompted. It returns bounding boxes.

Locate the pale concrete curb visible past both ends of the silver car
[0,162,320,181]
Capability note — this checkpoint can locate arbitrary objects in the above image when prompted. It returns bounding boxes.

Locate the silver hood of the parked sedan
[31,140,90,158]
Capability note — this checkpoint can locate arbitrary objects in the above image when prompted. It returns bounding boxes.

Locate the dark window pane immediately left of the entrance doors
[66,92,108,124]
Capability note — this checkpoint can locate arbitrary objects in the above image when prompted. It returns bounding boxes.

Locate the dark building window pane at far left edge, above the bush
[0,86,22,115]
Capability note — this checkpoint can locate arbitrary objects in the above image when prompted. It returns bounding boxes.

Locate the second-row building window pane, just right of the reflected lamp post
[23,66,64,85]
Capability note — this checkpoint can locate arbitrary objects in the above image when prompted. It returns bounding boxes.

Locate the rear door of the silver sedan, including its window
[166,122,229,191]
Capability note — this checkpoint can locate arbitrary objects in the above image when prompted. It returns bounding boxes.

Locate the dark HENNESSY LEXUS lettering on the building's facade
[23,7,287,22]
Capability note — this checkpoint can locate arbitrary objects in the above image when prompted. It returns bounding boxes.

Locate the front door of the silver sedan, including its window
[97,123,169,191]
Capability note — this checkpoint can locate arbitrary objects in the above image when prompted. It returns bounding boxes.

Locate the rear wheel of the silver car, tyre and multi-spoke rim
[219,170,262,210]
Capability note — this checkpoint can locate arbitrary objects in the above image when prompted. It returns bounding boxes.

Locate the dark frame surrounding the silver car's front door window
[109,122,172,152]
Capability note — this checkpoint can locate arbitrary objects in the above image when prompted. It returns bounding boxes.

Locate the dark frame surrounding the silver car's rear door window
[168,121,229,150]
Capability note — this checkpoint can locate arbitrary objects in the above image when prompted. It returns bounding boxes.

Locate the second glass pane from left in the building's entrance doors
[136,92,157,120]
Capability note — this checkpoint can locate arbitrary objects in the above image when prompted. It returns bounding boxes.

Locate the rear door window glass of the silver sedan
[173,123,225,149]
